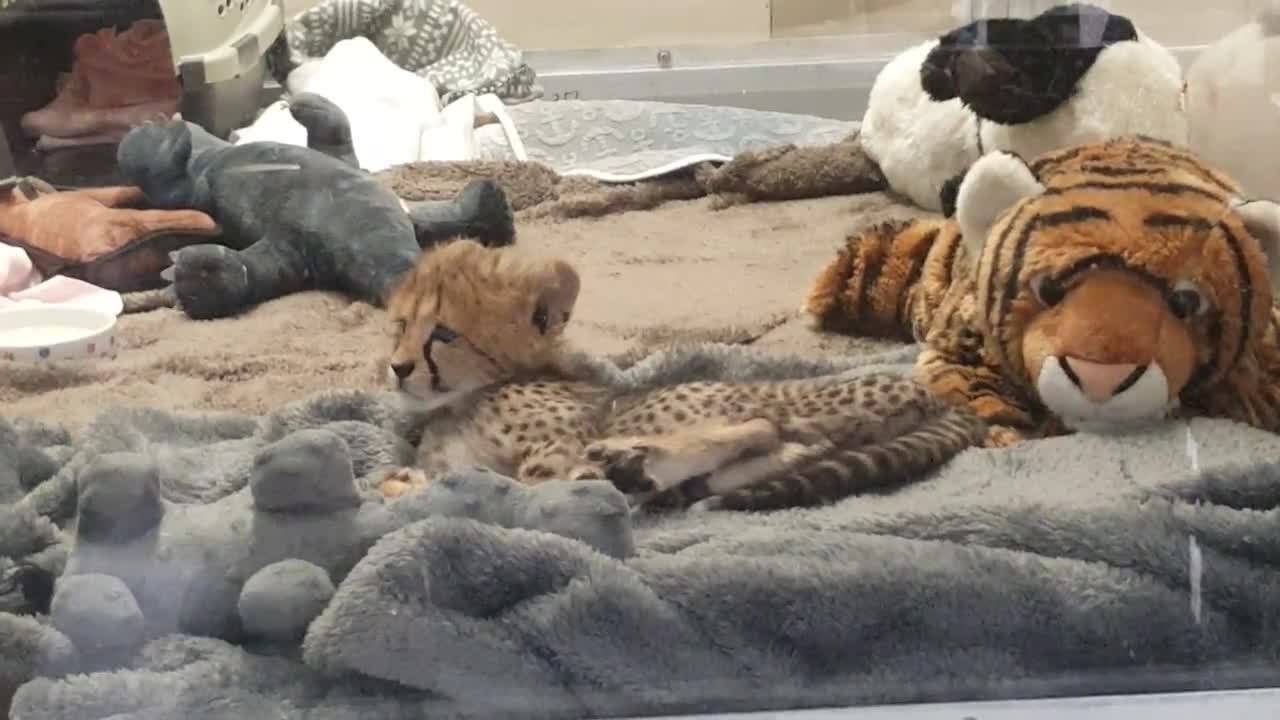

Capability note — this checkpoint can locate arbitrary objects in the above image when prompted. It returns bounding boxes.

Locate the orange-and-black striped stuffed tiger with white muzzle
[803,137,1280,446]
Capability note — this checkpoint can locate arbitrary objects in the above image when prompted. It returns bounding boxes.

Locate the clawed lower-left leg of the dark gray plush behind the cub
[161,238,306,320]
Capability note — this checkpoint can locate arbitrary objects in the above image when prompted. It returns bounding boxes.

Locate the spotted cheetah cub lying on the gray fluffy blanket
[380,240,984,510]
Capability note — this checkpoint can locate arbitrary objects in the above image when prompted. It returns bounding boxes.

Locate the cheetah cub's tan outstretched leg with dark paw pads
[577,418,781,496]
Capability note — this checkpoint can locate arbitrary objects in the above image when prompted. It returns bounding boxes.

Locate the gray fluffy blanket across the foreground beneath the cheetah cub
[0,347,1280,720]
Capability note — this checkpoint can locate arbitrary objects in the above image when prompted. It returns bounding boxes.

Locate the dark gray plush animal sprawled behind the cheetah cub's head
[116,95,515,319]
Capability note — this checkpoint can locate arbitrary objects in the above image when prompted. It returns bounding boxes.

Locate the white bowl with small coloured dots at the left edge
[0,305,115,363]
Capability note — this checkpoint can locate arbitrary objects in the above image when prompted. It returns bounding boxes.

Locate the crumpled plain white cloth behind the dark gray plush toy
[232,37,525,172]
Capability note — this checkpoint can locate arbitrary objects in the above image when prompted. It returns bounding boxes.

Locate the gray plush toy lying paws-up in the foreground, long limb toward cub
[30,435,635,655]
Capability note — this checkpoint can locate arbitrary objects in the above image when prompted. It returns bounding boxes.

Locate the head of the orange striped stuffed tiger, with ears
[956,138,1280,429]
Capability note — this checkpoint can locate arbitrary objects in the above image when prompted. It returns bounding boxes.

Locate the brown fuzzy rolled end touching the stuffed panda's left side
[705,135,888,206]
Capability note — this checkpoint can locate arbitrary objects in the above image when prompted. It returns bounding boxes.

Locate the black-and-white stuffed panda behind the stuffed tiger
[860,4,1188,210]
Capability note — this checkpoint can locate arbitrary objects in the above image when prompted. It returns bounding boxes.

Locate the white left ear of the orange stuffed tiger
[955,151,1044,261]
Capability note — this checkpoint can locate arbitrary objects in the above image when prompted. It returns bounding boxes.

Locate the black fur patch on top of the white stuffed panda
[920,3,1139,126]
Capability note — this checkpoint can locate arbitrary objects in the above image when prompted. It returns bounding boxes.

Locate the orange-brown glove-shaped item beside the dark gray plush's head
[0,178,220,292]
